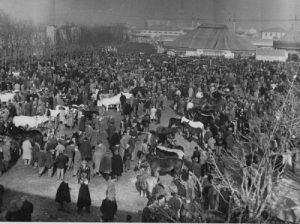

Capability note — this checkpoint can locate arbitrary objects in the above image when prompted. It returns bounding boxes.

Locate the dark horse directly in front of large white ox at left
[7,123,44,148]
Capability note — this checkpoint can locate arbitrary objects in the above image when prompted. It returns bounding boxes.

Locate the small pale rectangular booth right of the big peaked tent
[256,48,288,62]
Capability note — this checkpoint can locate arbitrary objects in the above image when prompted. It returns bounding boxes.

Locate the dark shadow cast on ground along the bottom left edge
[0,189,140,222]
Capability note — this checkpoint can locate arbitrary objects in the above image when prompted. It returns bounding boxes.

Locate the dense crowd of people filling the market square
[0,51,299,221]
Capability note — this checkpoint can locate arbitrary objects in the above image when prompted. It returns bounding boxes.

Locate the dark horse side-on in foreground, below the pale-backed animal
[146,154,183,176]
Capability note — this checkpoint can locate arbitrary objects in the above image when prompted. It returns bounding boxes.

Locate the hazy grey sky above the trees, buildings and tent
[0,0,300,29]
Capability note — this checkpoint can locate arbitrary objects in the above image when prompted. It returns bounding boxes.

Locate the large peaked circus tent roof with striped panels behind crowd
[166,25,255,51]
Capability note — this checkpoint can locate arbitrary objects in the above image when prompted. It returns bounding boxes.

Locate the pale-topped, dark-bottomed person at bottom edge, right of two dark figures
[100,181,118,222]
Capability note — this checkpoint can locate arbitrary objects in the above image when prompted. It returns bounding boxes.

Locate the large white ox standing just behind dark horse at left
[13,116,49,128]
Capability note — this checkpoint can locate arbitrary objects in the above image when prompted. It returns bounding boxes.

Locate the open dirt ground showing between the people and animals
[0,102,300,222]
